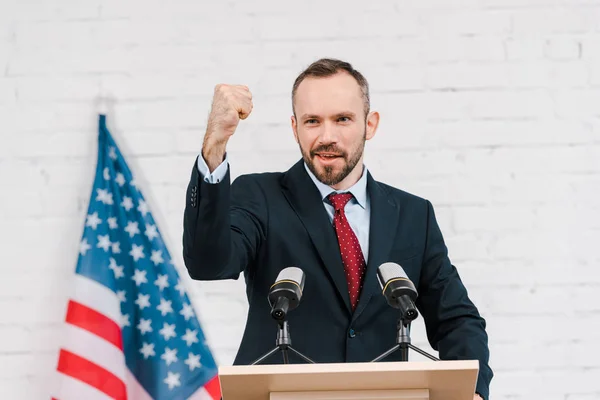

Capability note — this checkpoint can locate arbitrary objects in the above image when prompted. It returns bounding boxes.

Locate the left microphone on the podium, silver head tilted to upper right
[269,267,305,322]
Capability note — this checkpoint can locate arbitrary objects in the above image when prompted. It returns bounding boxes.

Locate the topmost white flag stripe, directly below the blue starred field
[71,274,121,323]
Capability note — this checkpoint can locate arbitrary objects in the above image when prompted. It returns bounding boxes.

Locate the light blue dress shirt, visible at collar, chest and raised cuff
[198,155,371,262]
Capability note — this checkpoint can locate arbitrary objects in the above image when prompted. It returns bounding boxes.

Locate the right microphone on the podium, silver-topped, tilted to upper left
[377,262,419,321]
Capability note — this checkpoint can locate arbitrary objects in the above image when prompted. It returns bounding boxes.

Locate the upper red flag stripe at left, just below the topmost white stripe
[66,300,123,350]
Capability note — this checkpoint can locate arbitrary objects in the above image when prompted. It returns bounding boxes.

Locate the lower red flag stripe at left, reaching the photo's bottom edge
[57,349,127,399]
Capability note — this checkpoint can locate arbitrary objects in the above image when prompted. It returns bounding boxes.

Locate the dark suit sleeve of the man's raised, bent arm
[183,158,267,280]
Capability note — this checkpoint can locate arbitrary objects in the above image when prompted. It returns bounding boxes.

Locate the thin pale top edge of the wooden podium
[219,360,479,376]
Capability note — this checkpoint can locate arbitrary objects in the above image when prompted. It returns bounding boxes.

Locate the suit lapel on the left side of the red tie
[282,160,352,313]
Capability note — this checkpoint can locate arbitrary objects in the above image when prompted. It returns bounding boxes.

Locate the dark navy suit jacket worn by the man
[183,161,492,398]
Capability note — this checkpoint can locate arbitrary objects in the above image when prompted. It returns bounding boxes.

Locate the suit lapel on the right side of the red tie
[352,174,399,320]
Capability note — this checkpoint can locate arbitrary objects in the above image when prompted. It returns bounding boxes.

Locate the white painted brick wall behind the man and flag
[0,0,600,400]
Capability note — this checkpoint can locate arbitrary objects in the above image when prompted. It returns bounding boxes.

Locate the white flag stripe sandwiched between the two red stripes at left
[62,324,127,381]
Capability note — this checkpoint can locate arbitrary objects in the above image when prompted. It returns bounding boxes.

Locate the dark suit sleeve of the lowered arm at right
[417,201,493,400]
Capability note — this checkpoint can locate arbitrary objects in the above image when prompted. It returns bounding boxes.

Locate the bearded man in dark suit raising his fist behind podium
[183,59,492,399]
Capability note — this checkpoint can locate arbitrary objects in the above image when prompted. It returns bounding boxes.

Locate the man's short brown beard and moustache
[300,131,367,186]
